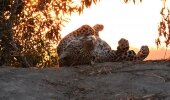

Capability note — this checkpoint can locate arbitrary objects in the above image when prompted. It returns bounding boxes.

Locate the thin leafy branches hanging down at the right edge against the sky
[156,0,170,47]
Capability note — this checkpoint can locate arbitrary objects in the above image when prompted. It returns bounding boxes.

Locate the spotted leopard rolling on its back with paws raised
[57,24,149,66]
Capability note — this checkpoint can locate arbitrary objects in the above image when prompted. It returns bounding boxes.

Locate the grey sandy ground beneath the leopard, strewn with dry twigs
[0,60,170,100]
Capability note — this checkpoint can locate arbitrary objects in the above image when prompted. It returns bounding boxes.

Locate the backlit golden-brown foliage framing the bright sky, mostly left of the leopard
[0,0,170,67]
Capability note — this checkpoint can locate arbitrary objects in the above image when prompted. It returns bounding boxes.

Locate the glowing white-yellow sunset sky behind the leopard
[61,0,170,59]
